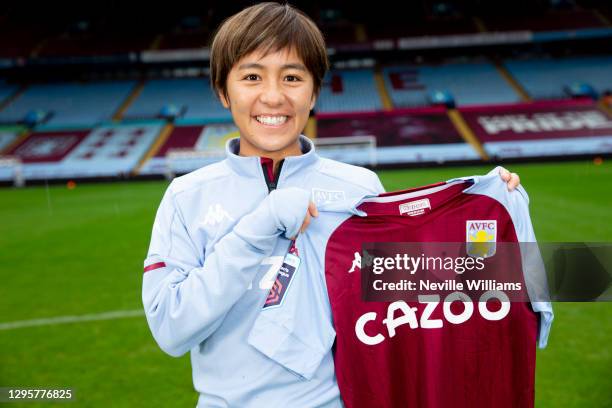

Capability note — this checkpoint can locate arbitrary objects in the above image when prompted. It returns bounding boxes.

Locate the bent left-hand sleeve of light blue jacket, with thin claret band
[142,185,309,357]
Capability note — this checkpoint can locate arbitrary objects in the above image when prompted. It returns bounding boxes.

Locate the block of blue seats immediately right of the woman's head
[316,69,382,113]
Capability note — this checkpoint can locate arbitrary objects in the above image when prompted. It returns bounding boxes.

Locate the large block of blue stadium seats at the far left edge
[0,81,136,126]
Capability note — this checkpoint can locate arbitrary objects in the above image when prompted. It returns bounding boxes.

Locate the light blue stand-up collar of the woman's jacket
[225,135,320,178]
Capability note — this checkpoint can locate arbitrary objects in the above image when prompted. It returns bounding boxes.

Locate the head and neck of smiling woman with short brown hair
[210,3,329,167]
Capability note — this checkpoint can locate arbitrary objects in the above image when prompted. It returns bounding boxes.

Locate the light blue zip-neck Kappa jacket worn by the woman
[142,136,383,407]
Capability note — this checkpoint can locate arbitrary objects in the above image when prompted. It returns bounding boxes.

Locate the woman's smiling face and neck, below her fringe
[221,49,315,159]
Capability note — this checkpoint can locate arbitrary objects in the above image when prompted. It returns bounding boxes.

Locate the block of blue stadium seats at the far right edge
[504,56,612,99]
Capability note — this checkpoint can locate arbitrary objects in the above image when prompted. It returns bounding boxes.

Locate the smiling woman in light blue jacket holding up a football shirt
[143,3,518,407]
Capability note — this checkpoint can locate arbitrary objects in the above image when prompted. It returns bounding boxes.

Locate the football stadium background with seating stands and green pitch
[0,0,612,407]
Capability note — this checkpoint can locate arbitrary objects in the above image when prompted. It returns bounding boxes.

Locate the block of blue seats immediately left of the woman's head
[123,78,231,121]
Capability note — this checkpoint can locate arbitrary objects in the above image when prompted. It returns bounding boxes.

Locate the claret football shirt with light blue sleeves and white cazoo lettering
[249,169,553,407]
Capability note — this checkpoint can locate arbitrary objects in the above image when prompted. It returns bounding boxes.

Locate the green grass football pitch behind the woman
[0,161,612,407]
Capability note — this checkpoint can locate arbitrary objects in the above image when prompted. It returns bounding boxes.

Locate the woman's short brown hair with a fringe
[210,2,329,103]
